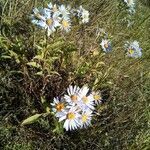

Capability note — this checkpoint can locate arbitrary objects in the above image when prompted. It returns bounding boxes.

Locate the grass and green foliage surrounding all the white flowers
[0,0,150,150]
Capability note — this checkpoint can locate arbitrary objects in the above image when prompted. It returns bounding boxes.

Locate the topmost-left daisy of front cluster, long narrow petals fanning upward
[64,85,80,105]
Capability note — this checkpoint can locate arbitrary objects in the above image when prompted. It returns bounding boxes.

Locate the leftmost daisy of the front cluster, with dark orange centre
[51,97,65,117]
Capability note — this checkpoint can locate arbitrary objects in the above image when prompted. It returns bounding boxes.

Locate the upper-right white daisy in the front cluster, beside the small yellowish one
[78,86,95,111]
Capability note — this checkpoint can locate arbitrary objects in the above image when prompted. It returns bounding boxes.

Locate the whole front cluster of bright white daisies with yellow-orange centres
[51,85,102,131]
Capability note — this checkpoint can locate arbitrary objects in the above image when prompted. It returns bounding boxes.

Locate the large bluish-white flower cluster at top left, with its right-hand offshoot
[31,3,89,36]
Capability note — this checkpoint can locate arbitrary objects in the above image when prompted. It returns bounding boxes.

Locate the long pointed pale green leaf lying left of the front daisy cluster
[21,114,42,125]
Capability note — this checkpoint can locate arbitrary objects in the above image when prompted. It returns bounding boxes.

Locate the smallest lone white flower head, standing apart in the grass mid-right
[100,39,112,52]
